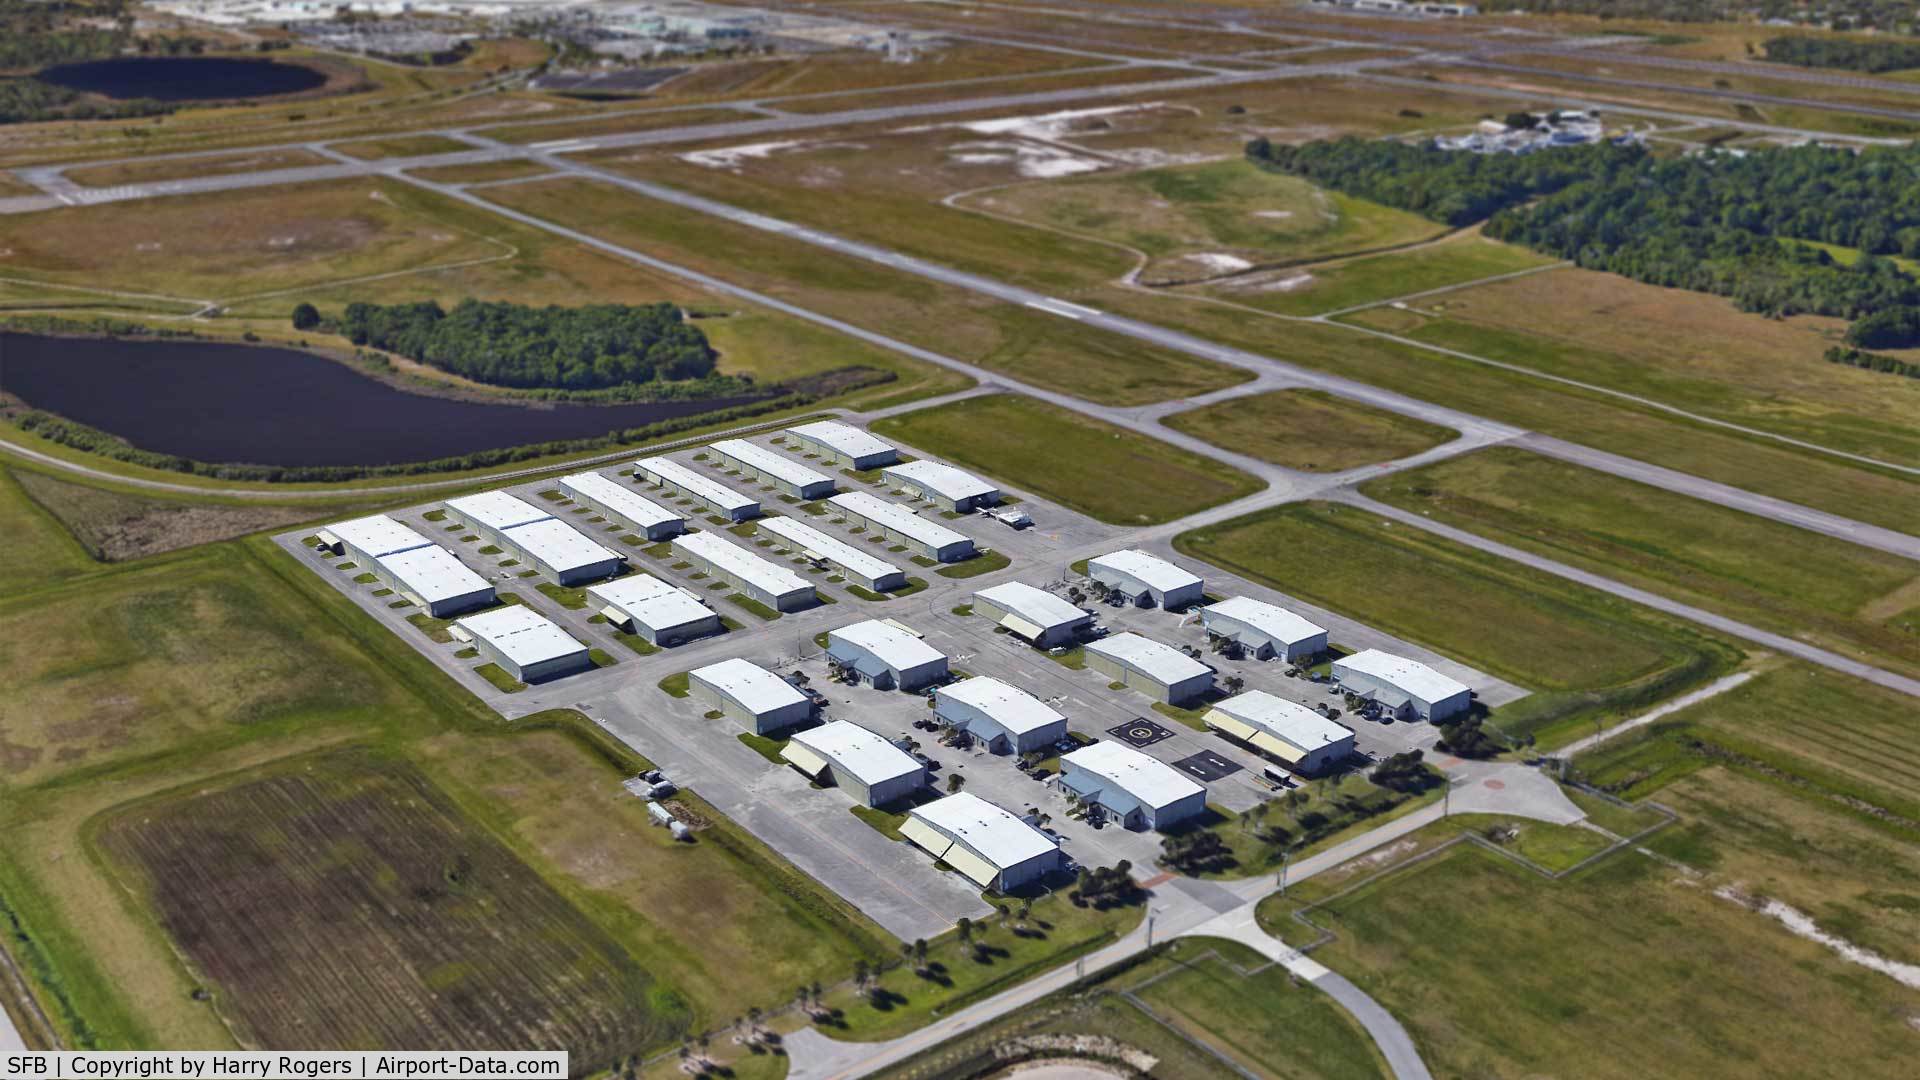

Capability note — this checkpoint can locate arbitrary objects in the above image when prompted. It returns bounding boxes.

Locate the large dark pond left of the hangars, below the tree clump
[0,334,764,465]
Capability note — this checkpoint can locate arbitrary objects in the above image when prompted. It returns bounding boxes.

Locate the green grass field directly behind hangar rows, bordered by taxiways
[874,394,1261,525]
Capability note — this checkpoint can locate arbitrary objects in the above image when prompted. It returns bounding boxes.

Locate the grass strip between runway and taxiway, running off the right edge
[1363,448,1920,673]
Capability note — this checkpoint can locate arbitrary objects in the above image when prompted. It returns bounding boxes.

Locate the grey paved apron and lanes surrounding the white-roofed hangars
[276,424,1521,940]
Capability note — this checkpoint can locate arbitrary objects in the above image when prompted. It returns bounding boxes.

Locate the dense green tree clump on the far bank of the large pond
[307,300,718,390]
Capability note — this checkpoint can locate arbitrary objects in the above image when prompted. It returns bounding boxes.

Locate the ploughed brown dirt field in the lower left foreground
[100,751,680,1070]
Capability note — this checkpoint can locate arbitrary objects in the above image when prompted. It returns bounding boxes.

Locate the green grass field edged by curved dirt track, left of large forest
[968,161,1442,284]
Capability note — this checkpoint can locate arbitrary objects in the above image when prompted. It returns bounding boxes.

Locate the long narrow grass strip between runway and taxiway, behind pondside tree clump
[488,181,1248,404]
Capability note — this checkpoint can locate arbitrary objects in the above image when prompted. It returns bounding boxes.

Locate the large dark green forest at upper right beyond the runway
[1246,138,1920,340]
